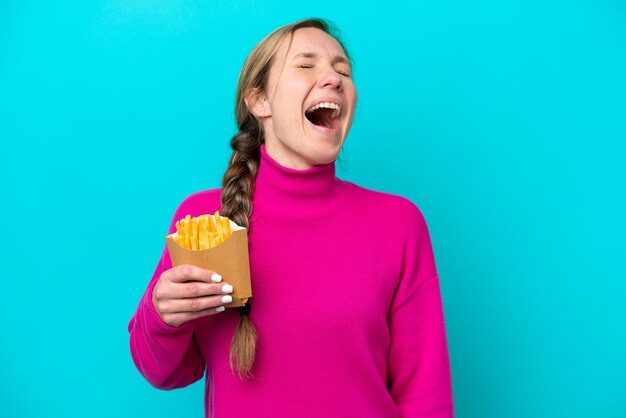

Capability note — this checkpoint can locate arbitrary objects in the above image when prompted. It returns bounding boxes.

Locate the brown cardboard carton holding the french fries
[165,221,252,308]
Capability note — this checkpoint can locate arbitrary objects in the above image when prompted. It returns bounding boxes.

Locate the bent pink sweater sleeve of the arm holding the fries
[128,198,210,390]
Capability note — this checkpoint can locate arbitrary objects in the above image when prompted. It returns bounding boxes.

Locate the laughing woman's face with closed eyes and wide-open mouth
[253,28,357,170]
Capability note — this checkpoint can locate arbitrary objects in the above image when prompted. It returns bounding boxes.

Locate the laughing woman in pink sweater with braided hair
[129,19,453,418]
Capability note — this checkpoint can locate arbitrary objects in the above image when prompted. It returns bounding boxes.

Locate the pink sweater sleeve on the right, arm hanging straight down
[388,206,454,418]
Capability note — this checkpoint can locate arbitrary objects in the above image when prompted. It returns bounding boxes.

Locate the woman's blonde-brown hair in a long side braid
[221,18,347,379]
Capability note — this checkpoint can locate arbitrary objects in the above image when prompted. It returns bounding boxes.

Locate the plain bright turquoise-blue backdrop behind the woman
[0,0,626,418]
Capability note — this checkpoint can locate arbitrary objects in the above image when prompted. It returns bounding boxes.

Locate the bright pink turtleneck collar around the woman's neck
[252,144,343,213]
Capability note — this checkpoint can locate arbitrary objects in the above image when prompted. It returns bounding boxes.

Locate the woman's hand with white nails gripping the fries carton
[152,264,233,327]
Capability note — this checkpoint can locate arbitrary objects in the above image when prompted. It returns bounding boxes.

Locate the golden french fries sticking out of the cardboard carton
[172,211,233,251]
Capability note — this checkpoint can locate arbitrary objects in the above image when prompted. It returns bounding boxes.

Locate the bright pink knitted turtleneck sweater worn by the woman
[128,148,453,418]
